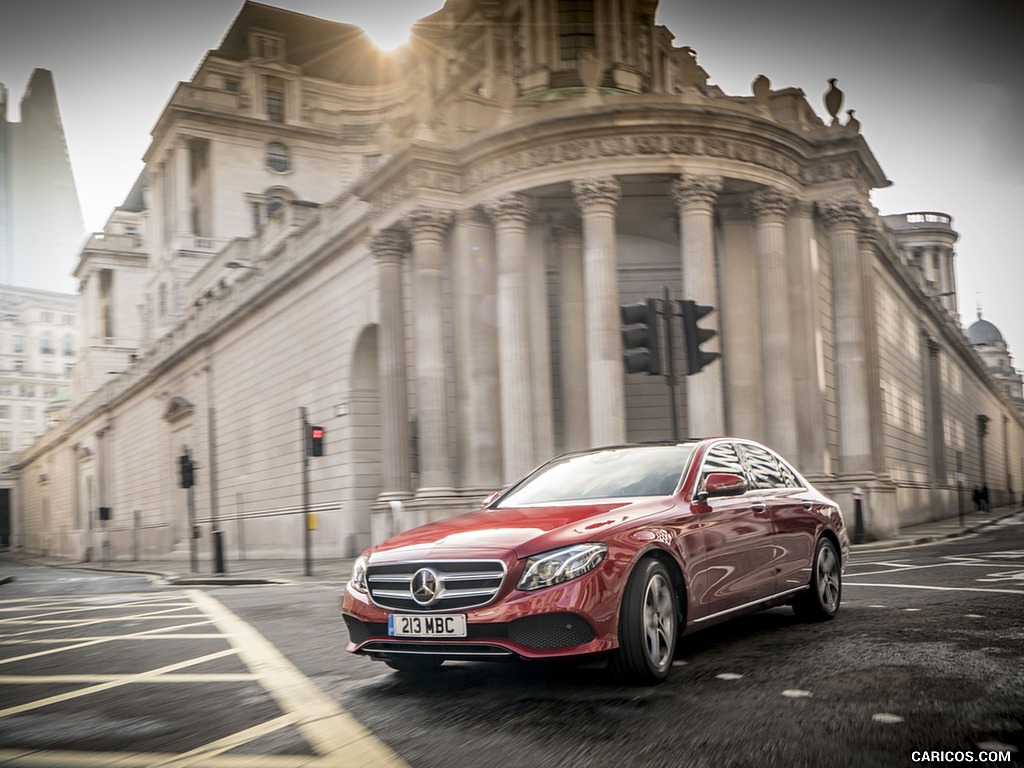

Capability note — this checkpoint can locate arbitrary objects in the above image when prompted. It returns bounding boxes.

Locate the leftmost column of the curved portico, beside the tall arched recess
[370,229,411,497]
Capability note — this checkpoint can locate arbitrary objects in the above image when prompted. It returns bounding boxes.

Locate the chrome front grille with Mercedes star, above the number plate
[367,560,505,611]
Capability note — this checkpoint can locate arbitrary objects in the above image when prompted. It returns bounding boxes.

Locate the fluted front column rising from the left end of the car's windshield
[485,194,537,482]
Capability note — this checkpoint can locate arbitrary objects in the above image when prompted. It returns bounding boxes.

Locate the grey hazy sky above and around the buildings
[0,0,1024,360]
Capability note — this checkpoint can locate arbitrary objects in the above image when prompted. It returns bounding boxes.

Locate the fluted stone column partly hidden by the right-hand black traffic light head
[673,174,726,436]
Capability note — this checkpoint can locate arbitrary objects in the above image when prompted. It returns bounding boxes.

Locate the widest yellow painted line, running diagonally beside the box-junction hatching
[186,590,406,768]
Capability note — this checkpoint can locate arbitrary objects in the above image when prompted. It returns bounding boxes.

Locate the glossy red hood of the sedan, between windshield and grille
[364,498,674,562]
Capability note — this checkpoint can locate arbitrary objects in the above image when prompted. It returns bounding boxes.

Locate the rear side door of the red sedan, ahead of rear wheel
[739,442,816,593]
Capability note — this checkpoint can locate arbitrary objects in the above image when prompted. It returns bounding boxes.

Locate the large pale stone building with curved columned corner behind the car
[9,0,1024,557]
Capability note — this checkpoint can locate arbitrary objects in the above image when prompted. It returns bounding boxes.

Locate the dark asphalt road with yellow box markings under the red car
[0,516,1024,768]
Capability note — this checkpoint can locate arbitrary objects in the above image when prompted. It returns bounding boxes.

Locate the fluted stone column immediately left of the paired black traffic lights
[572,176,626,445]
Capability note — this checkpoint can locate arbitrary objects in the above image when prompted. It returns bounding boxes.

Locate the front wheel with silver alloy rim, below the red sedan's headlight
[610,558,679,685]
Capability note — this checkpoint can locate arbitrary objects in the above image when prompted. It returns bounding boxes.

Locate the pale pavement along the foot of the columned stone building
[0,507,1024,589]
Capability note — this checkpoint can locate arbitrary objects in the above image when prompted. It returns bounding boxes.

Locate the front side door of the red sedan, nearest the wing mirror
[691,441,775,617]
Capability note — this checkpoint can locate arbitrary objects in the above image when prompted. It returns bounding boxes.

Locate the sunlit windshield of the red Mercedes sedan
[497,443,694,508]
